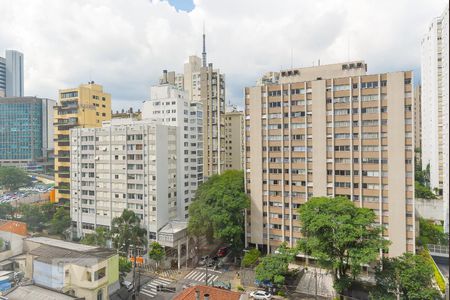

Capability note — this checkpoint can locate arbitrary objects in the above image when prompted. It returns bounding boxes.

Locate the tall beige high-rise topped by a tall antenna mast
[161,36,225,178]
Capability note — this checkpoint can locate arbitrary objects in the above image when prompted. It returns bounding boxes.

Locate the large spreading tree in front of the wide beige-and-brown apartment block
[298,197,387,293]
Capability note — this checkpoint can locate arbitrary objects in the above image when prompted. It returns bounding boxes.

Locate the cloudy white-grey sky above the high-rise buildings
[0,0,447,110]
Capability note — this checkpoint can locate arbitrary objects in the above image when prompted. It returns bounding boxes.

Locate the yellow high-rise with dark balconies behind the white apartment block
[54,81,111,203]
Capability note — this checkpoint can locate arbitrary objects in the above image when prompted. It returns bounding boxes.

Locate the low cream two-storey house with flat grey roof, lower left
[22,237,120,300]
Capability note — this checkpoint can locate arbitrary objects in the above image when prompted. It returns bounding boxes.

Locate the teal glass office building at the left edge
[0,97,56,172]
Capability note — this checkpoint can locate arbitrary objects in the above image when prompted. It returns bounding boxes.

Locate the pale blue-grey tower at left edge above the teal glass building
[0,50,24,97]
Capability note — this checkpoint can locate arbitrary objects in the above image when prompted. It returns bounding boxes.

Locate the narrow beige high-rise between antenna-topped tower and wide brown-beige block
[224,108,245,170]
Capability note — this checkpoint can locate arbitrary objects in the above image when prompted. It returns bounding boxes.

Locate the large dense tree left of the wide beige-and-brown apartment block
[188,170,250,249]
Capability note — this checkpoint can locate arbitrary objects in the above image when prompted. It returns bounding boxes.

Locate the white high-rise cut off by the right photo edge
[421,5,450,232]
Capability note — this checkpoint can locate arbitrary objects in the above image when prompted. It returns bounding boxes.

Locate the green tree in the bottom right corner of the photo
[371,253,441,300]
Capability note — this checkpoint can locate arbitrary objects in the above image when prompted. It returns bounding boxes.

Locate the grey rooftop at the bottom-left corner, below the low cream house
[5,284,77,300]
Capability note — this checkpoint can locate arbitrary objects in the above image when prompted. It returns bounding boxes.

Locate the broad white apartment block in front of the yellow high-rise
[70,119,177,240]
